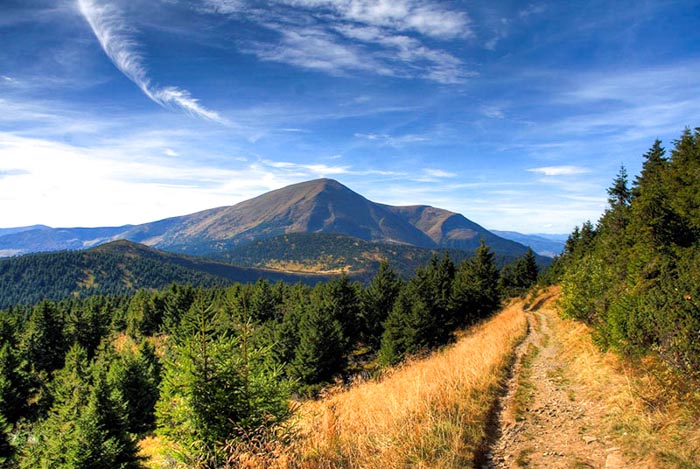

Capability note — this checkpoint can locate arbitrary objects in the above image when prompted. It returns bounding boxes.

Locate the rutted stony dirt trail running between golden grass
[482,296,629,469]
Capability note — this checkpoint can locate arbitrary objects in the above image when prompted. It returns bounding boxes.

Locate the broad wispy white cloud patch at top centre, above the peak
[205,0,475,84]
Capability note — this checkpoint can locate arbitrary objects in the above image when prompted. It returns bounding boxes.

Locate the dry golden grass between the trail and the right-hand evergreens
[551,290,700,468]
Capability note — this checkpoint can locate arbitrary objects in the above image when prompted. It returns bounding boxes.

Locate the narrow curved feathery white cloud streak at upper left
[78,0,228,124]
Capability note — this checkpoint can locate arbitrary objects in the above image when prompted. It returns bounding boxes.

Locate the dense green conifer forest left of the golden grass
[0,243,538,468]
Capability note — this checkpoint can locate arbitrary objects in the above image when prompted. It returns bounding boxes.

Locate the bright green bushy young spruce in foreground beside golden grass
[156,298,286,467]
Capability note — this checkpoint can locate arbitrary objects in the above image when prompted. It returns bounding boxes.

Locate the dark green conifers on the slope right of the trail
[553,129,700,378]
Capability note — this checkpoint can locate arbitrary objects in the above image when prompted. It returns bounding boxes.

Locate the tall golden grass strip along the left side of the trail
[274,304,527,469]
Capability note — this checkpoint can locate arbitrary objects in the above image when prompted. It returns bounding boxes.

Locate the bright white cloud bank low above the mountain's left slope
[0,132,301,226]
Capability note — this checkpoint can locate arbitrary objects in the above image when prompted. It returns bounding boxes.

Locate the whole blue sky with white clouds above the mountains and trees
[0,0,700,233]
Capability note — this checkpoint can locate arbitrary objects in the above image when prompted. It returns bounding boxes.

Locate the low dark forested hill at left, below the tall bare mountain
[0,241,329,308]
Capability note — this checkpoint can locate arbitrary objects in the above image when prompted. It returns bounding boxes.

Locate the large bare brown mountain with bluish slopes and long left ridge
[0,179,526,256]
